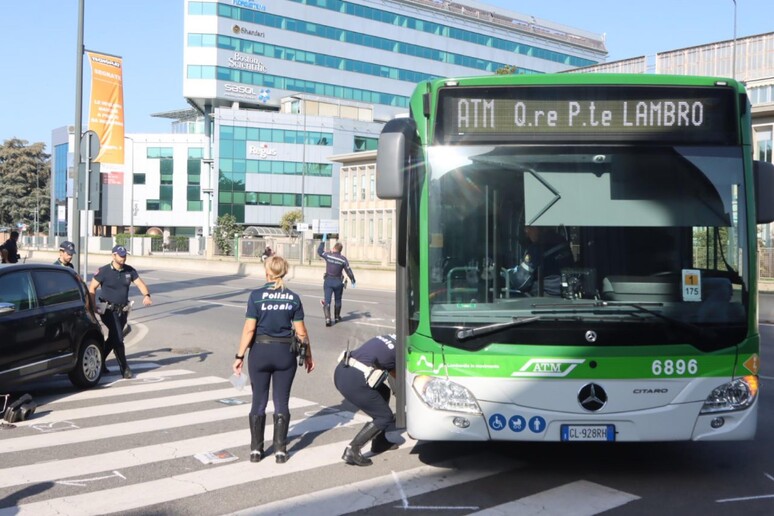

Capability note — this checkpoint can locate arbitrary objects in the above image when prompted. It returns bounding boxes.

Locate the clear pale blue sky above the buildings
[0,0,774,152]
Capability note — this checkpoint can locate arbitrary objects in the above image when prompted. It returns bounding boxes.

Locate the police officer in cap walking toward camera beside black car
[89,245,153,378]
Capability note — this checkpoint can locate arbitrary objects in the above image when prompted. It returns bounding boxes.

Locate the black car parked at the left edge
[0,264,105,393]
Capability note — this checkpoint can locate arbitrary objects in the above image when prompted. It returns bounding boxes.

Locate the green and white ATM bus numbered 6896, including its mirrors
[376,74,774,441]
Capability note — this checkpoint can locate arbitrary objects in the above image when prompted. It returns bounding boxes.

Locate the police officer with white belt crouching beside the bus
[333,334,398,466]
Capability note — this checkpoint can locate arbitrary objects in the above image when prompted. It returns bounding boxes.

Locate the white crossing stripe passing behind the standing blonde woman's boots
[0,411,370,489]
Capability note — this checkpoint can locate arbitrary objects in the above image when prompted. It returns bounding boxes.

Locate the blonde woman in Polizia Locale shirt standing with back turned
[233,255,314,463]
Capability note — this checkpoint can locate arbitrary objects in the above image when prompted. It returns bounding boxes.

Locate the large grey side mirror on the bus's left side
[376,118,417,199]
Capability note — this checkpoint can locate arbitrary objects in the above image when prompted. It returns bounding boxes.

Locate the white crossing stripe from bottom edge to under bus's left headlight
[231,453,512,516]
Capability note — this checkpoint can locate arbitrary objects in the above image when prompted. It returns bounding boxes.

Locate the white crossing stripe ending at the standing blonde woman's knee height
[16,387,251,426]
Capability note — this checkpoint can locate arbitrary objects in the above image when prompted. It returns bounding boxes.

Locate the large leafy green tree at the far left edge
[0,138,51,233]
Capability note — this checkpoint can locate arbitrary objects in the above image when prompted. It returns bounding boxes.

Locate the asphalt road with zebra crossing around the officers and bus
[0,269,774,516]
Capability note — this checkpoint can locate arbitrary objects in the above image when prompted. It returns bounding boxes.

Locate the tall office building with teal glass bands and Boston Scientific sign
[183,0,607,226]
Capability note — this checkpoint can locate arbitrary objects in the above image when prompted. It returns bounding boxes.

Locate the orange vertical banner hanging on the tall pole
[86,52,124,164]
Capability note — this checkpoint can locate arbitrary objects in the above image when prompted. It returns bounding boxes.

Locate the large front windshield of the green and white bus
[427,142,749,348]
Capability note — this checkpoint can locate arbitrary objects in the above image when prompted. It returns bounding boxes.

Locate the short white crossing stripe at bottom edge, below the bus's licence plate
[473,480,640,516]
